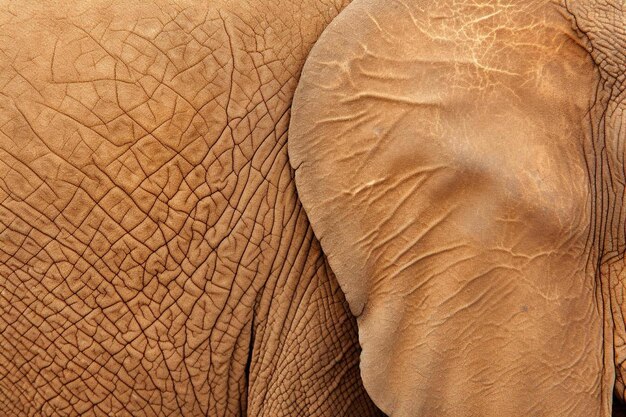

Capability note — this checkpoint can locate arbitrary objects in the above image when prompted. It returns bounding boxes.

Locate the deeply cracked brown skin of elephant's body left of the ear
[0,0,379,417]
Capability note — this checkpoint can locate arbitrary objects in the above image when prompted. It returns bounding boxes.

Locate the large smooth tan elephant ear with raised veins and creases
[289,0,613,417]
